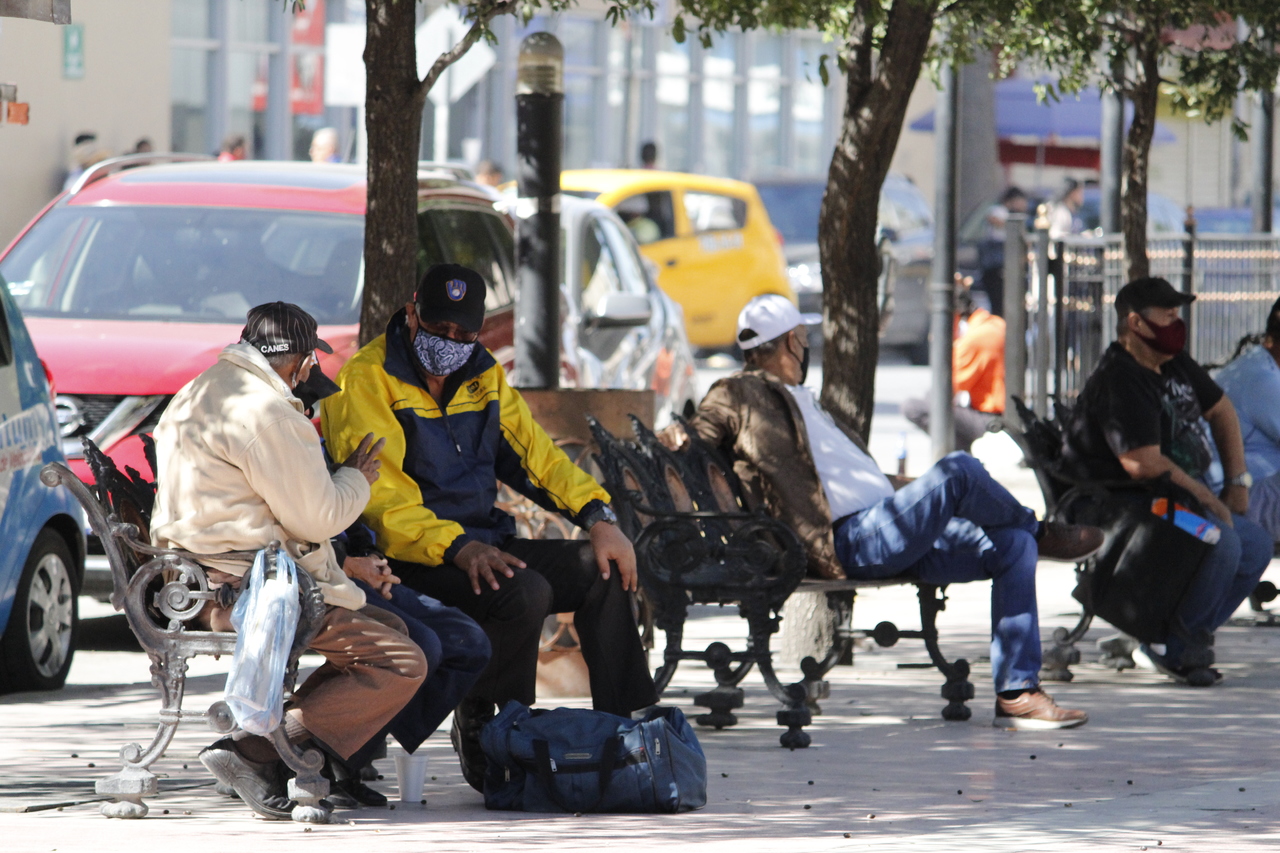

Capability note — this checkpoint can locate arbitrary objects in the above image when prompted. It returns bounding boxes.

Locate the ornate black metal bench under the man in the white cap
[588,416,973,749]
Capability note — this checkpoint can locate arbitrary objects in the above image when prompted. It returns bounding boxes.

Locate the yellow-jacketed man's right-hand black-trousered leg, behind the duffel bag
[504,539,658,716]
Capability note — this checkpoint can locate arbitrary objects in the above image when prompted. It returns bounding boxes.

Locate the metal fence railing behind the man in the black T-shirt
[1027,234,1280,412]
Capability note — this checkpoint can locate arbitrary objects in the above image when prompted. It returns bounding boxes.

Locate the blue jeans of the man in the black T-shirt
[1165,514,1272,666]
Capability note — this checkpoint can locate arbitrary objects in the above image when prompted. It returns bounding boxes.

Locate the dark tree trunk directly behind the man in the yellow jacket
[360,0,425,346]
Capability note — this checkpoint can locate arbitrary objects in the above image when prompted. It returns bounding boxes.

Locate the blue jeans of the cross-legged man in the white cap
[835,453,1041,693]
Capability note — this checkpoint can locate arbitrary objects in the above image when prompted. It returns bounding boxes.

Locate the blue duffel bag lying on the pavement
[480,701,707,812]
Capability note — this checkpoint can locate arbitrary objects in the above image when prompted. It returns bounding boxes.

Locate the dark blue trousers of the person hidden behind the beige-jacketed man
[352,580,489,766]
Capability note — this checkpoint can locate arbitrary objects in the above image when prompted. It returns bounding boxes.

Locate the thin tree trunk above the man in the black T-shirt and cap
[1120,33,1160,282]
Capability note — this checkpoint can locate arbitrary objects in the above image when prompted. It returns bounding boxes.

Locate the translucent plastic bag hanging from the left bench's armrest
[225,548,301,735]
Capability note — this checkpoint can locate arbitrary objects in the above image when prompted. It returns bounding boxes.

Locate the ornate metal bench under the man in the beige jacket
[40,439,329,824]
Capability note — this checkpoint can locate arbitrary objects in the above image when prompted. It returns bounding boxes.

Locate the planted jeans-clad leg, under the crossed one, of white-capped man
[915,519,1041,693]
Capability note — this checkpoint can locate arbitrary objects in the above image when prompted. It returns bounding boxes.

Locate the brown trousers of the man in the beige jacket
[206,594,426,758]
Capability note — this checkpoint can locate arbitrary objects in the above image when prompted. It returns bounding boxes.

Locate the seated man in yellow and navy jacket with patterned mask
[321,264,658,790]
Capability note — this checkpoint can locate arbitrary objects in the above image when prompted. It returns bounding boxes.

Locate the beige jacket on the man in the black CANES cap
[151,343,369,610]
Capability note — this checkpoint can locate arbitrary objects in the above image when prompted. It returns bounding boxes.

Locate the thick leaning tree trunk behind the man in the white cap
[818,0,937,438]
